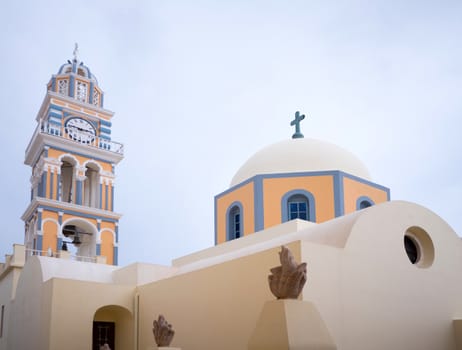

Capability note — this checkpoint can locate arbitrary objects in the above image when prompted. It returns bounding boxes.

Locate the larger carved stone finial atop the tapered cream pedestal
[268,246,306,299]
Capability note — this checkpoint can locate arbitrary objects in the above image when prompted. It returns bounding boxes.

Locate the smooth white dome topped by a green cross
[231,138,370,187]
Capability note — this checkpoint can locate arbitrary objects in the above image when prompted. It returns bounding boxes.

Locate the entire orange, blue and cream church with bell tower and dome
[0,51,462,350]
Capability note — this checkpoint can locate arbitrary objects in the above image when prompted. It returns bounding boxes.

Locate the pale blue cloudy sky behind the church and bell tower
[0,0,462,265]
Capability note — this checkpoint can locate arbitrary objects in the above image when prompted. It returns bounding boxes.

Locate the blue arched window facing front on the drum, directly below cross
[281,190,316,222]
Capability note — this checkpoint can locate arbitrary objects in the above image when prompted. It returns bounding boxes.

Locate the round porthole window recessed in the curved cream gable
[404,226,435,267]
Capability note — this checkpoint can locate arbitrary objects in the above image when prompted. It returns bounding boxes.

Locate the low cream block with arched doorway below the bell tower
[5,257,136,350]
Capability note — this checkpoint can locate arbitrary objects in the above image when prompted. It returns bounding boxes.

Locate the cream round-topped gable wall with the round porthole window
[302,201,462,350]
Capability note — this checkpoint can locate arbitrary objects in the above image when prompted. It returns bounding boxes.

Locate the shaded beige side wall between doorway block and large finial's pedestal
[138,242,300,350]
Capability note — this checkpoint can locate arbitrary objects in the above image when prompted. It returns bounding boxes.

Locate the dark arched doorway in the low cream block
[92,305,133,350]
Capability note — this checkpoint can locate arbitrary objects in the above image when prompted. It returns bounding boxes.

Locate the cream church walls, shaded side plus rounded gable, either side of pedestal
[139,201,462,350]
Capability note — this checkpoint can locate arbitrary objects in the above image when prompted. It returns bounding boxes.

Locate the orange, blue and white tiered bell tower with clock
[22,45,123,265]
